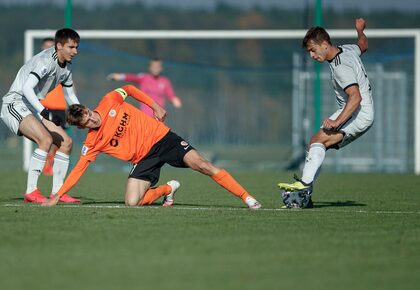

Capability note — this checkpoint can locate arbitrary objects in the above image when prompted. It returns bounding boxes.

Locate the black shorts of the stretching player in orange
[128,131,194,186]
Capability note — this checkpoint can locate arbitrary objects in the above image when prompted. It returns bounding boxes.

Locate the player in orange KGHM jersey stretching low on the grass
[44,85,261,209]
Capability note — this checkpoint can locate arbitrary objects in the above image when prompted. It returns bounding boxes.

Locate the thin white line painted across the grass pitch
[3,203,420,215]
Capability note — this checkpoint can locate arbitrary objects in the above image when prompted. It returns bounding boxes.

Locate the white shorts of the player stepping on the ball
[330,105,374,149]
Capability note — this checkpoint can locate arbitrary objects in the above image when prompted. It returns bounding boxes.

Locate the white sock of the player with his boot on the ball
[302,143,325,184]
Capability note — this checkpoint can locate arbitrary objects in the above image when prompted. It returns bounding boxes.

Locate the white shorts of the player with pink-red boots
[0,95,41,136]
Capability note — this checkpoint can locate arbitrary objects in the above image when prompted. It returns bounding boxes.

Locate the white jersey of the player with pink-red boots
[3,47,73,101]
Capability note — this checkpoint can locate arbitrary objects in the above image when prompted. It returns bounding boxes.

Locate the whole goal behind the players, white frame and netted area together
[7,30,420,172]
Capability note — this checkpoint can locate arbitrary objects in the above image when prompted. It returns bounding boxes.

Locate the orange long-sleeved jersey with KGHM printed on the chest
[57,85,170,195]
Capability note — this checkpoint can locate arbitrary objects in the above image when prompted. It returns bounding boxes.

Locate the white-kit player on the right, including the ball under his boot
[278,18,374,207]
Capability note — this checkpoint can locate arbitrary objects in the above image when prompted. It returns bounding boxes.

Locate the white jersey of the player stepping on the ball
[329,44,373,108]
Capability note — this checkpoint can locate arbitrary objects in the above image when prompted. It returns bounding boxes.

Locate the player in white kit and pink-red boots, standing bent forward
[1,28,80,203]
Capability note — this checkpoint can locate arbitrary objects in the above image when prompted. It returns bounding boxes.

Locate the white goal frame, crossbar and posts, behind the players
[23,29,420,174]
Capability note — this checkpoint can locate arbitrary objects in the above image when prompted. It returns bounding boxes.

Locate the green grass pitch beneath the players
[0,169,420,290]
